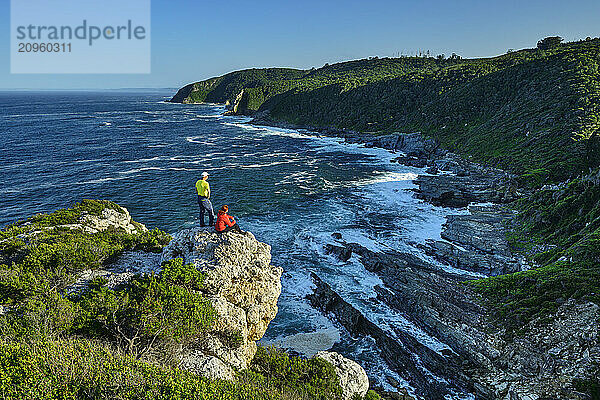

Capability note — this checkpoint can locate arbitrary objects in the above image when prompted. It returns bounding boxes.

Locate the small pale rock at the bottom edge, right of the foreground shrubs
[315,351,369,400]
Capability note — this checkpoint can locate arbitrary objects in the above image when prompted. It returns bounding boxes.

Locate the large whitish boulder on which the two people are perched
[161,228,283,376]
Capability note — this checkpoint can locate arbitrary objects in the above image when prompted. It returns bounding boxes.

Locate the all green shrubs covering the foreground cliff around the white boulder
[0,200,356,400]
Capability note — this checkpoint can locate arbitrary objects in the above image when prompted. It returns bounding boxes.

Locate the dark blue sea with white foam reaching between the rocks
[0,91,468,394]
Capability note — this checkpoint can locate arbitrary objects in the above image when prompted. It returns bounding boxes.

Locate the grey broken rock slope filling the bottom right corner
[477,299,600,400]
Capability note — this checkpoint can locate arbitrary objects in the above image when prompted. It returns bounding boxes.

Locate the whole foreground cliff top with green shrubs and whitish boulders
[0,200,377,400]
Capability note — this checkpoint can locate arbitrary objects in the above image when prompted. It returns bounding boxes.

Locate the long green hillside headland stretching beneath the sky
[171,39,600,183]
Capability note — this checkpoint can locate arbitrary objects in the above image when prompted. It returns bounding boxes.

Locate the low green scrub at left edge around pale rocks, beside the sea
[0,200,171,304]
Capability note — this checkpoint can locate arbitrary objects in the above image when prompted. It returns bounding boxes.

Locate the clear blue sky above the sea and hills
[0,0,600,89]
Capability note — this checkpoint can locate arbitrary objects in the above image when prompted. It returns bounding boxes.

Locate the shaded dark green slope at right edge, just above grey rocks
[472,170,600,331]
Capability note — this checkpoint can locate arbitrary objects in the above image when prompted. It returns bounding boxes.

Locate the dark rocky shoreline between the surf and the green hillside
[241,116,600,400]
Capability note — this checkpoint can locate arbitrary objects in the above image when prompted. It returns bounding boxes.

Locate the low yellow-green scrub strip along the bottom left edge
[0,340,282,400]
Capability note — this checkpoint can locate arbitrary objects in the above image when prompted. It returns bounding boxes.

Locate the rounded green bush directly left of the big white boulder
[74,259,216,356]
